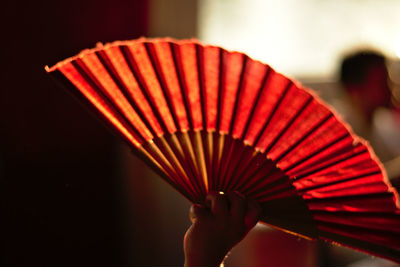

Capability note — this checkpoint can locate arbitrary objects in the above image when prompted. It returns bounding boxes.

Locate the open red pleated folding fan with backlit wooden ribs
[47,38,400,262]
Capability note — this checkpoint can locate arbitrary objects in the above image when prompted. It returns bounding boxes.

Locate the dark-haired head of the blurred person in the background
[340,51,391,119]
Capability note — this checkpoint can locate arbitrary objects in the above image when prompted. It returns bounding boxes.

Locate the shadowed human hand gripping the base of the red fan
[184,192,261,267]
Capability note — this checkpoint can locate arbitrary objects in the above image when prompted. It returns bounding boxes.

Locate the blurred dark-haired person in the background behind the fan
[337,50,400,188]
